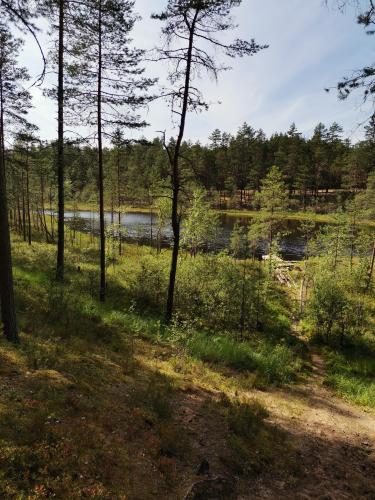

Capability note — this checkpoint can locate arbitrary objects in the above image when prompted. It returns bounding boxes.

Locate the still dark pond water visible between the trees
[50,210,319,260]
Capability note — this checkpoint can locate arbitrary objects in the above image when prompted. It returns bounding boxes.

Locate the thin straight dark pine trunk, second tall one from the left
[56,0,65,281]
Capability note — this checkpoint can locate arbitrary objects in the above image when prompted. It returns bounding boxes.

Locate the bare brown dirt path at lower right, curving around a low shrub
[174,355,375,500]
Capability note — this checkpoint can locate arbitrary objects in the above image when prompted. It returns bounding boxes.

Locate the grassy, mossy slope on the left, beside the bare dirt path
[0,235,302,499]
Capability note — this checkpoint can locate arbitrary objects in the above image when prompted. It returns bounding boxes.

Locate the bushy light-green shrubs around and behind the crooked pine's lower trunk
[132,254,289,335]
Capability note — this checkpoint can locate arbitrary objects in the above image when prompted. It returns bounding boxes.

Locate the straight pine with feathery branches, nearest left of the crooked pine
[68,0,154,301]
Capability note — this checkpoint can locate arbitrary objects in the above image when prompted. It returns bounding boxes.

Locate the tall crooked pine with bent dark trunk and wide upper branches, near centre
[152,0,264,322]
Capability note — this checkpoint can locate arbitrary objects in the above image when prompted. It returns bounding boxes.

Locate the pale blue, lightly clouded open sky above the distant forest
[22,0,375,143]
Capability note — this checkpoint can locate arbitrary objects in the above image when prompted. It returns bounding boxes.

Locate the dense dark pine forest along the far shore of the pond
[8,120,375,212]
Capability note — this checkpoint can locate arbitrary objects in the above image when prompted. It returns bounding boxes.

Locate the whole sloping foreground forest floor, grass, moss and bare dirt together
[0,237,375,500]
